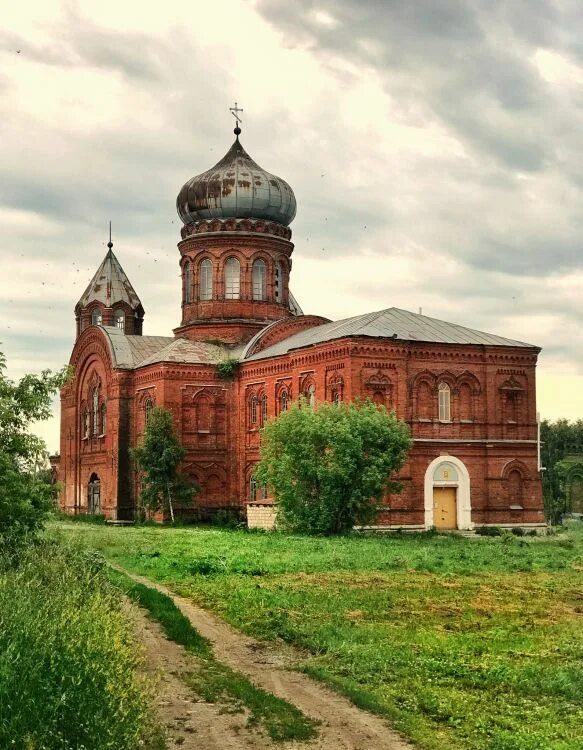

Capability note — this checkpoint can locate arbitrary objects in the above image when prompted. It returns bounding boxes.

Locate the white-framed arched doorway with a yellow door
[425,456,473,529]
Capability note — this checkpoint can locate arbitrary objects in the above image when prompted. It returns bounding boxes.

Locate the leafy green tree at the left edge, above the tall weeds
[0,353,68,549]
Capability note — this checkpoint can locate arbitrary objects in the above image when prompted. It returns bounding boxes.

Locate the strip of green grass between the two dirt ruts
[108,569,318,741]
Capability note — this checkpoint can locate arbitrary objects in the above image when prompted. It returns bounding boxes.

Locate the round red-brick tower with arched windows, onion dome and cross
[174,114,302,344]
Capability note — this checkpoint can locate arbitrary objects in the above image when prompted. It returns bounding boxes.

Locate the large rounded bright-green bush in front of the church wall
[255,400,412,534]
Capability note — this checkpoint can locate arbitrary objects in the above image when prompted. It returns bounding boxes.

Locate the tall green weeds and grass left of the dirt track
[0,542,159,750]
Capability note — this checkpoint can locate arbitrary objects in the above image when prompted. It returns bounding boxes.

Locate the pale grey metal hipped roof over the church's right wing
[247,307,538,361]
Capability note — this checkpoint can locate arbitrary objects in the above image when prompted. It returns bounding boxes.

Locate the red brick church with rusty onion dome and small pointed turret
[59,120,544,529]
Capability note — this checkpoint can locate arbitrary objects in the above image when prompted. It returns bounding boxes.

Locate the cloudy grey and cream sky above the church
[0,0,583,450]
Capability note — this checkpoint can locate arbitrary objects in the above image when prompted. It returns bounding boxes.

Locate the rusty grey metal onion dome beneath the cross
[176,137,296,226]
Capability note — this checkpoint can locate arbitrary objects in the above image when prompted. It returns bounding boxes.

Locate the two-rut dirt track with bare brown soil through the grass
[120,568,413,750]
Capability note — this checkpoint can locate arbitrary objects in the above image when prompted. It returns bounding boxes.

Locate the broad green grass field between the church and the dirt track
[58,524,583,750]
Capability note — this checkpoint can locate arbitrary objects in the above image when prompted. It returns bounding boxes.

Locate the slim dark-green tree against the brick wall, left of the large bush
[131,407,195,521]
